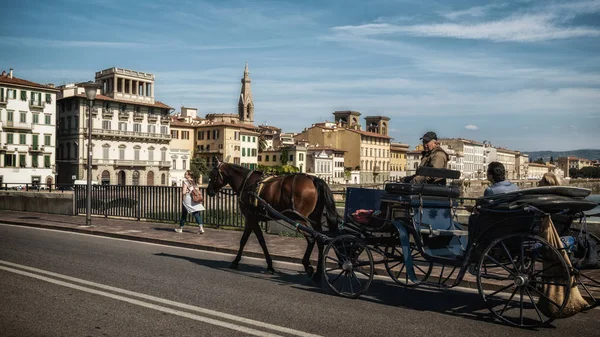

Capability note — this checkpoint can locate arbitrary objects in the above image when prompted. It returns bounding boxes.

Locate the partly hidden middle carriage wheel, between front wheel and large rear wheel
[384,244,433,287]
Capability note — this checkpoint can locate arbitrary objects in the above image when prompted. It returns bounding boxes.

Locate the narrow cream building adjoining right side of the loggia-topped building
[169,107,202,186]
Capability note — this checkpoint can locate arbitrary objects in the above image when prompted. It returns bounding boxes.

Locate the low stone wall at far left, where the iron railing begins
[0,191,75,215]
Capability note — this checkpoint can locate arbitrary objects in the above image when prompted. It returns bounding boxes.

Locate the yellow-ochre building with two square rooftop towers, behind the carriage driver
[295,111,391,183]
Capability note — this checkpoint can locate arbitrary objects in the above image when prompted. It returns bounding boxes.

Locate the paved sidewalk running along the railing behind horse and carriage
[0,210,600,291]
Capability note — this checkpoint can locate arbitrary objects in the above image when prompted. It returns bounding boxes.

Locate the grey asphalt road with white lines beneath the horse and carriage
[0,224,600,337]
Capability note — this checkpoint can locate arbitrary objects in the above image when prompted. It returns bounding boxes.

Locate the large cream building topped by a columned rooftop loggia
[57,68,172,185]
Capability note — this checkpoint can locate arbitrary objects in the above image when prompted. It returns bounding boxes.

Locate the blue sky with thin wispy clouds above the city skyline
[0,0,600,151]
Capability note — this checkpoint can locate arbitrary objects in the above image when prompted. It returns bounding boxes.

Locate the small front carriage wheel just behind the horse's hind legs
[323,235,375,298]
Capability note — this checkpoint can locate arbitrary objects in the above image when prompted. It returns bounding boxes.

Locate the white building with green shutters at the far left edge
[0,69,58,188]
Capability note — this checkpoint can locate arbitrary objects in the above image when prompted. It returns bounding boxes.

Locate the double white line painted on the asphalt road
[0,260,319,337]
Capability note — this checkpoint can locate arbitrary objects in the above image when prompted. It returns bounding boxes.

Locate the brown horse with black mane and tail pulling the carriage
[206,160,342,282]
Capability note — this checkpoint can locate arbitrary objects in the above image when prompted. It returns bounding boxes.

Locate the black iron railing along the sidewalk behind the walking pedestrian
[74,185,244,227]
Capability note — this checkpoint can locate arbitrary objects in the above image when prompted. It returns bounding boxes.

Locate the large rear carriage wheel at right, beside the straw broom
[477,234,571,328]
